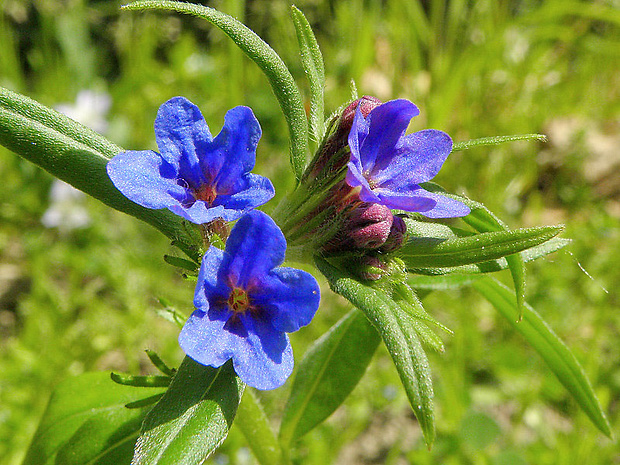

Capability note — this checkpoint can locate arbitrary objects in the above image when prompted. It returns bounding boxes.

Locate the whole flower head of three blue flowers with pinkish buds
[108,97,469,389]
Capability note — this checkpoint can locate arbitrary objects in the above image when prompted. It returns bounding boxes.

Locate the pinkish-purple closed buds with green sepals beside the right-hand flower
[275,96,406,280]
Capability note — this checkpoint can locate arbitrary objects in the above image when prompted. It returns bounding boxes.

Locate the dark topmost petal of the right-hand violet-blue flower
[352,99,420,173]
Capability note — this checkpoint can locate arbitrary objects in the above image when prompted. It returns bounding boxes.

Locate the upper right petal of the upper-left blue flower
[200,106,261,195]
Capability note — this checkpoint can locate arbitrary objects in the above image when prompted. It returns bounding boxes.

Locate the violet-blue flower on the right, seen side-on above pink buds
[346,99,469,218]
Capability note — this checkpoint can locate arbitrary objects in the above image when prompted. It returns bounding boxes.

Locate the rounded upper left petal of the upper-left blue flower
[155,97,213,189]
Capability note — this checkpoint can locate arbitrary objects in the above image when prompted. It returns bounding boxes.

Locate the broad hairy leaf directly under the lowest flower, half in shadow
[132,357,245,465]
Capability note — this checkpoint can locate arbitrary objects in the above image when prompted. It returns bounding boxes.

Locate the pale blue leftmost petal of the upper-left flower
[106,150,192,209]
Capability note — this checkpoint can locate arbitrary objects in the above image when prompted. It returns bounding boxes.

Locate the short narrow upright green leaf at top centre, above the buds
[291,5,325,143]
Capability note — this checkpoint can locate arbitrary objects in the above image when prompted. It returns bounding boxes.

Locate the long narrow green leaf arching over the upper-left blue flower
[122,0,308,180]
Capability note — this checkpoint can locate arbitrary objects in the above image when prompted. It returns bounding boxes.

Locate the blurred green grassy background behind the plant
[0,0,620,465]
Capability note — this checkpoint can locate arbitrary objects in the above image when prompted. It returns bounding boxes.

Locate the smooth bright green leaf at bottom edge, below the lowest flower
[235,389,285,465]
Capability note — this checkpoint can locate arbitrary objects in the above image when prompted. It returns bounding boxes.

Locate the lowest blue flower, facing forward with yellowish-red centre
[179,210,320,389]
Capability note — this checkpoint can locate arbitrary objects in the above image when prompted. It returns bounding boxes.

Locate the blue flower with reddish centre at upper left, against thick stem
[107,97,274,224]
